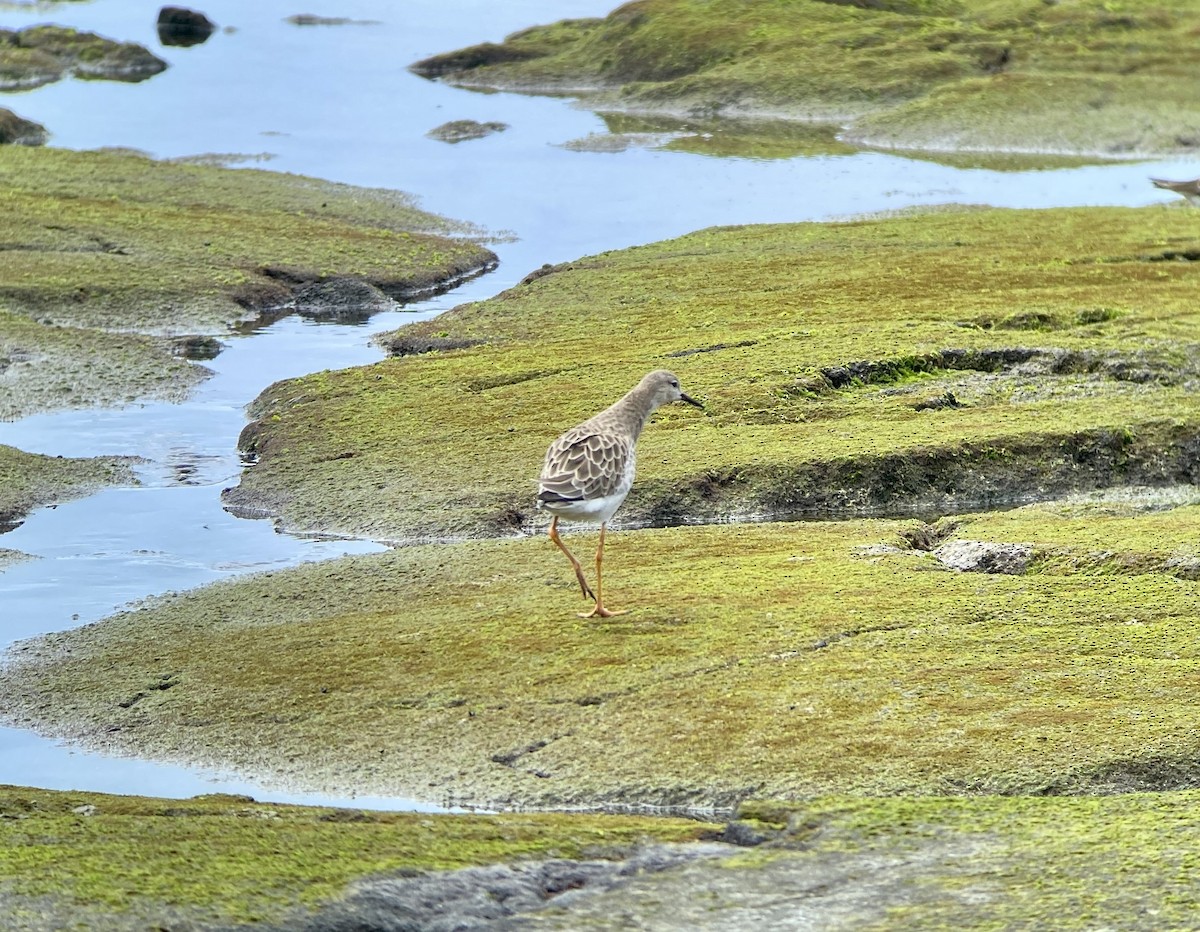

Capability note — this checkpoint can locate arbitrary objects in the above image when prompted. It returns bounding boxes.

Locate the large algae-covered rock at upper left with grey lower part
[0,146,496,417]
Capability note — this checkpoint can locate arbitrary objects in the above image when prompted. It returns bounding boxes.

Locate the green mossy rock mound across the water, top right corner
[413,0,1200,156]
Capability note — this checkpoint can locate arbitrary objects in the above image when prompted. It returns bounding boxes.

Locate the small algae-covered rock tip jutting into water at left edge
[0,444,137,527]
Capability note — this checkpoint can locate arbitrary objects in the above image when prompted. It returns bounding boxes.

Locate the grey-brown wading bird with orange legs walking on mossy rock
[538,369,704,618]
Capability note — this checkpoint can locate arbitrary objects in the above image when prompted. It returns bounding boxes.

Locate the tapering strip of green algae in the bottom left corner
[0,787,714,928]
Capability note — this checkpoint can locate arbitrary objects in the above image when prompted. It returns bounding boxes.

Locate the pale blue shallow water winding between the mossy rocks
[0,0,1196,808]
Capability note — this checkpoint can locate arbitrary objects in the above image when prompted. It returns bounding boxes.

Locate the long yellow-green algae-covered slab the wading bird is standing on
[7,506,1200,806]
